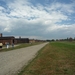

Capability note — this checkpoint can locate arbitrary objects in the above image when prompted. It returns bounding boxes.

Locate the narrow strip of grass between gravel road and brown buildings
[0,42,42,52]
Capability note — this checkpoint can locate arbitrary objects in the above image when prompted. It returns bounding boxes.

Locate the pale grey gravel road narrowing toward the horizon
[0,43,47,75]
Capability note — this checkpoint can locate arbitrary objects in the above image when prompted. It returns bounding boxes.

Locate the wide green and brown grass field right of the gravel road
[18,42,75,75]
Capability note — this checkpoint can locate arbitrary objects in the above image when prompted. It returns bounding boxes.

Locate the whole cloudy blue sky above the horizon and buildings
[0,0,75,39]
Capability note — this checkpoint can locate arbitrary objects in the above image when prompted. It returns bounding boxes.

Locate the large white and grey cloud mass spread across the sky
[0,0,75,37]
